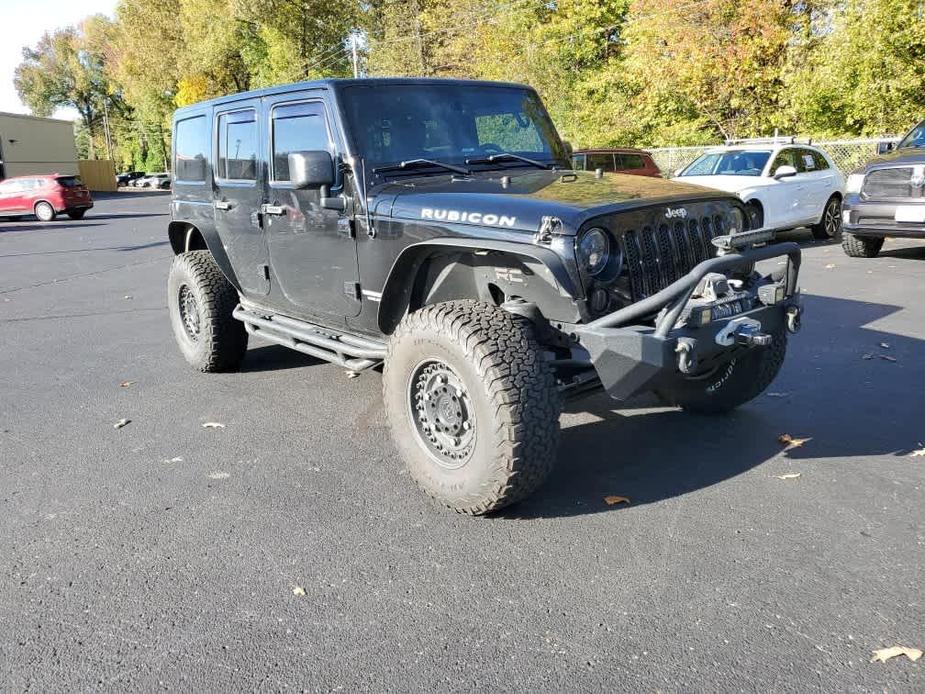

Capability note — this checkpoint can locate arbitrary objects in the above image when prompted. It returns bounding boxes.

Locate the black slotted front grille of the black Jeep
[623,214,726,301]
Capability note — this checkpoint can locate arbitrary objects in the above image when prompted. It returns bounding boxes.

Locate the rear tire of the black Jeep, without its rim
[167,251,247,372]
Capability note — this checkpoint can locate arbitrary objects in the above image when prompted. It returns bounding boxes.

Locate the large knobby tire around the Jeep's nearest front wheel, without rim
[383,301,561,515]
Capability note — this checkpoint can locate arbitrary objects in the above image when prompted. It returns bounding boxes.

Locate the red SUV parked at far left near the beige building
[0,174,93,222]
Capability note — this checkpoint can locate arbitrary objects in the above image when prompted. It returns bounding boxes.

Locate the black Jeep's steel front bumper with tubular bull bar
[572,243,802,400]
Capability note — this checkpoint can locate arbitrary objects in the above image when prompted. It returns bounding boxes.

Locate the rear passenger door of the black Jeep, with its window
[212,99,270,295]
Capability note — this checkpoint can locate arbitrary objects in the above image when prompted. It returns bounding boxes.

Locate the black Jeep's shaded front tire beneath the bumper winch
[661,328,787,414]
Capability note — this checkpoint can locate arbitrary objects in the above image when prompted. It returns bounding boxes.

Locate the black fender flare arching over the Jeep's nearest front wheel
[377,237,583,334]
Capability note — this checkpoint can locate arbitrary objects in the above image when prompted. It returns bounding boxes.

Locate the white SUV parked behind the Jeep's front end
[677,137,845,239]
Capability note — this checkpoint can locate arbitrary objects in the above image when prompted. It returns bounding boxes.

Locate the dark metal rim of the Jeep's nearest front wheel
[408,359,476,469]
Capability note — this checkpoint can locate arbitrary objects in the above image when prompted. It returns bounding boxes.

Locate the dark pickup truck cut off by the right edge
[842,121,925,258]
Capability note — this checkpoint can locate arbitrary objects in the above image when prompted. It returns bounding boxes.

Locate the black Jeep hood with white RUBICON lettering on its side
[370,169,730,233]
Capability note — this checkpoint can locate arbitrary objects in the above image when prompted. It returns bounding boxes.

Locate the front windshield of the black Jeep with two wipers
[343,83,568,174]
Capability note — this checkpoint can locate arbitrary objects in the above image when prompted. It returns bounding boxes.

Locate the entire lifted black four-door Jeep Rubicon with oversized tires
[168,79,800,514]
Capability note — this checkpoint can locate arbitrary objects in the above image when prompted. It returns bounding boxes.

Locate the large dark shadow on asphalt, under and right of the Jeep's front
[499,295,925,519]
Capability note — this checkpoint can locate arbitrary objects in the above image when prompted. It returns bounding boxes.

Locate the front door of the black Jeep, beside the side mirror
[264,92,362,320]
